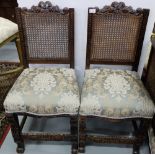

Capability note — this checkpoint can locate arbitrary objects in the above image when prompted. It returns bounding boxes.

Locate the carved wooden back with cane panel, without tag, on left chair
[16,1,74,68]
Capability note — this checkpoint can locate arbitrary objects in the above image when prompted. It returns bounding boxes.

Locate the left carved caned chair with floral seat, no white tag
[4,1,79,153]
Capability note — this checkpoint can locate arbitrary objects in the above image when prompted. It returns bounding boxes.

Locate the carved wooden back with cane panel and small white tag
[86,2,149,71]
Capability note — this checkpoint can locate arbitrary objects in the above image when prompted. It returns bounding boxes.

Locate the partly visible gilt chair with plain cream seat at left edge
[0,17,23,112]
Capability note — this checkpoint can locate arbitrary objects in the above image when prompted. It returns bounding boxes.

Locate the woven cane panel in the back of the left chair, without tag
[22,13,69,59]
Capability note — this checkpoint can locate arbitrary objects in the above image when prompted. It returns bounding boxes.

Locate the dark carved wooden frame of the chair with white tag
[79,2,151,153]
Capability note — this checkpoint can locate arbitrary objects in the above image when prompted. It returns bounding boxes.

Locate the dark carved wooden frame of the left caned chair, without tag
[6,2,78,153]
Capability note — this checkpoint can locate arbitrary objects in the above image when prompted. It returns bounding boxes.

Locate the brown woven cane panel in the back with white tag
[90,14,143,64]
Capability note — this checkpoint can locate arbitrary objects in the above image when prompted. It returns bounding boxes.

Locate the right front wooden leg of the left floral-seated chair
[70,116,78,154]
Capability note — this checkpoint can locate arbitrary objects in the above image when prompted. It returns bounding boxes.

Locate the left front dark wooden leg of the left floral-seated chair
[6,114,25,153]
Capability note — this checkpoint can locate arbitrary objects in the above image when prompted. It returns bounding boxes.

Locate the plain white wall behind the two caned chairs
[18,0,155,85]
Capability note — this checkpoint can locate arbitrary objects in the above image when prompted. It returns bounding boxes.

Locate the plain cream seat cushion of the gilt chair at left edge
[0,17,18,43]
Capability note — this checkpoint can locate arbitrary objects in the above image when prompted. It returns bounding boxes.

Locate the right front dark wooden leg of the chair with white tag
[133,120,150,154]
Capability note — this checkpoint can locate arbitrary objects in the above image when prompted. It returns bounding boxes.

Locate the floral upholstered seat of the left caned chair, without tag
[4,68,80,115]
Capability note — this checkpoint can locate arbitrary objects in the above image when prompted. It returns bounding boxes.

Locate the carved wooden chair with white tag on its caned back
[79,2,154,153]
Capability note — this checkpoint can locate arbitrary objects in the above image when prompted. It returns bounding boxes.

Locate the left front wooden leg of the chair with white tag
[79,116,86,153]
